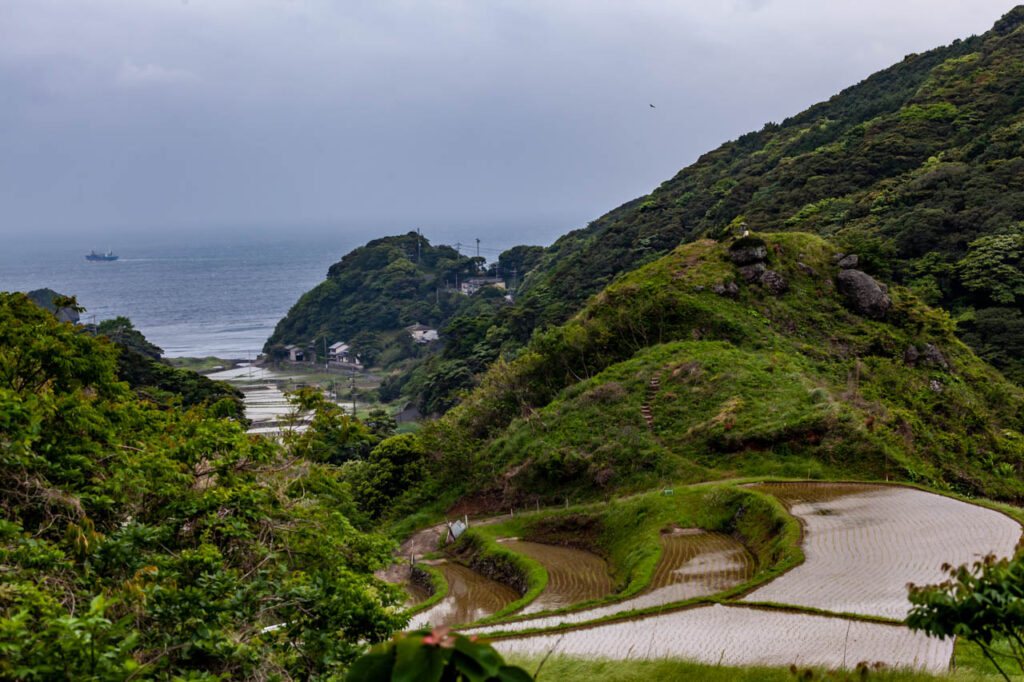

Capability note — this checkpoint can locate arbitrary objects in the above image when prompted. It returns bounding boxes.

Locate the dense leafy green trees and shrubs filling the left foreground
[0,294,404,680]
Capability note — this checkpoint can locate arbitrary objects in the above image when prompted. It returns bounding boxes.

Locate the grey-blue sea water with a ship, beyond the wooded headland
[0,236,360,358]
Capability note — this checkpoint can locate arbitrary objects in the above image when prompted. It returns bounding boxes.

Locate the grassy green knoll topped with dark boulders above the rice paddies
[413,232,1024,504]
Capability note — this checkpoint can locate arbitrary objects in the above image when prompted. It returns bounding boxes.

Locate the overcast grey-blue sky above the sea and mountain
[0,0,1014,241]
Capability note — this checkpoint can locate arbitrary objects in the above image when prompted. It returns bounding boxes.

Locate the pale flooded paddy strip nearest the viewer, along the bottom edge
[495,604,952,673]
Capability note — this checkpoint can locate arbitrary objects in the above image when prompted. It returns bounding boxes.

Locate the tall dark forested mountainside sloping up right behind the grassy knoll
[444,7,1024,381]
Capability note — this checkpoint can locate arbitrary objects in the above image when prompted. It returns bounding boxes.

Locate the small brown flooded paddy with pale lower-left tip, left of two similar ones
[409,563,519,630]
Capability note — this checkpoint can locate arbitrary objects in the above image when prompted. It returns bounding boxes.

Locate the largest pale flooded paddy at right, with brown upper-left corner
[745,483,1021,620]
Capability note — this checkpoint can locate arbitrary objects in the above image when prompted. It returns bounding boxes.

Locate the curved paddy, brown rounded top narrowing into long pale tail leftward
[472,528,754,633]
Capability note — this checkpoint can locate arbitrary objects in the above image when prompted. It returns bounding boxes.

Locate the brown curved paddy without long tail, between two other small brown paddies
[503,540,614,613]
